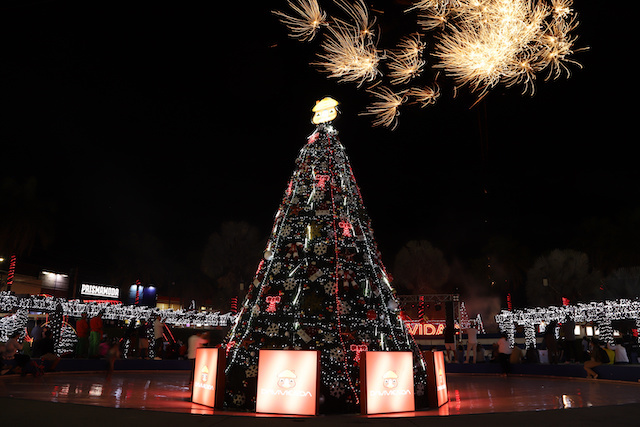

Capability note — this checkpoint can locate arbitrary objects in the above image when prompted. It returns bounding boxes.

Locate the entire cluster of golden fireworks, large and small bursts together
[274,0,585,128]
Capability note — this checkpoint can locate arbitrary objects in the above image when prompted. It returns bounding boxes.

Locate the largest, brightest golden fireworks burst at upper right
[422,0,577,98]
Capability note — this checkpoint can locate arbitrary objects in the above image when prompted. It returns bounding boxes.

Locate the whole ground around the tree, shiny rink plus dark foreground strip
[0,371,640,427]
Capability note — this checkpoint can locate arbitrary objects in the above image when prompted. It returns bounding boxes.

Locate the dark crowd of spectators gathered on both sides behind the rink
[0,313,629,379]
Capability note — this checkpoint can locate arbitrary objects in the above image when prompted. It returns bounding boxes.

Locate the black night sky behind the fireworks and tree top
[0,0,640,294]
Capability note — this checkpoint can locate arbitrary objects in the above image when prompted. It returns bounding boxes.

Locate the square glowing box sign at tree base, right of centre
[360,351,415,414]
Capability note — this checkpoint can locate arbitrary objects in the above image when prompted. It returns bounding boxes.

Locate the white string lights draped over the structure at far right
[496,299,640,348]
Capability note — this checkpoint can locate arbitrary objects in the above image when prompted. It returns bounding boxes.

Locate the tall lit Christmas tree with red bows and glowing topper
[225,98,426,412]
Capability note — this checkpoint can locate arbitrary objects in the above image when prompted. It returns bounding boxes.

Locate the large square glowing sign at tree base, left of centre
[256,350,320,415]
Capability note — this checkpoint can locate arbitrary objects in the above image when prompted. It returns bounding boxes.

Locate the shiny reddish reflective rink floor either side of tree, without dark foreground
[0,371,640,417]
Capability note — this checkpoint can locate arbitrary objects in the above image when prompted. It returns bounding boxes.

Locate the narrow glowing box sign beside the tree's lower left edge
[191,347,225,408]
